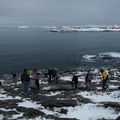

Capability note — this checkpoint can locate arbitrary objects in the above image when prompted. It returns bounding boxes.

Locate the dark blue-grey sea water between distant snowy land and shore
[0,27,120,74]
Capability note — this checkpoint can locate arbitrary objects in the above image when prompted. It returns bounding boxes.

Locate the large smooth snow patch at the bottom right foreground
[61,103,120,120]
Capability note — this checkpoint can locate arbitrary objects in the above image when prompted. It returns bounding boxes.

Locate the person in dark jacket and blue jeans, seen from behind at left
[21,69,30,95]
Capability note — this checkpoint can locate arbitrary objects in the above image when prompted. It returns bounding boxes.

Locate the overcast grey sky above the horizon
[0,0,120,25]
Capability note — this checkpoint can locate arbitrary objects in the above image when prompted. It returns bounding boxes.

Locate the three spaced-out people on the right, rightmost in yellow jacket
[71,69,109,91]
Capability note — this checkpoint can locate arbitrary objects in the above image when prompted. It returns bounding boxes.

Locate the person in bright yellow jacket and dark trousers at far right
[100,69,109,90]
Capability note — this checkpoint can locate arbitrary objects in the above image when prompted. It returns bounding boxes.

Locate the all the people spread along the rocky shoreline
[12,69,109,95]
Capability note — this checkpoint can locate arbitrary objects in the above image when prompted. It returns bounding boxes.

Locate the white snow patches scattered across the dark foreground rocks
[0,70,120,120]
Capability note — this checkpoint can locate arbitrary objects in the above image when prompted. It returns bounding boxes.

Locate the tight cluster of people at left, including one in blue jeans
[21,69,40,95]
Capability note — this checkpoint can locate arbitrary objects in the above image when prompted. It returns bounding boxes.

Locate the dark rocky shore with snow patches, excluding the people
[0,69,120,120]
